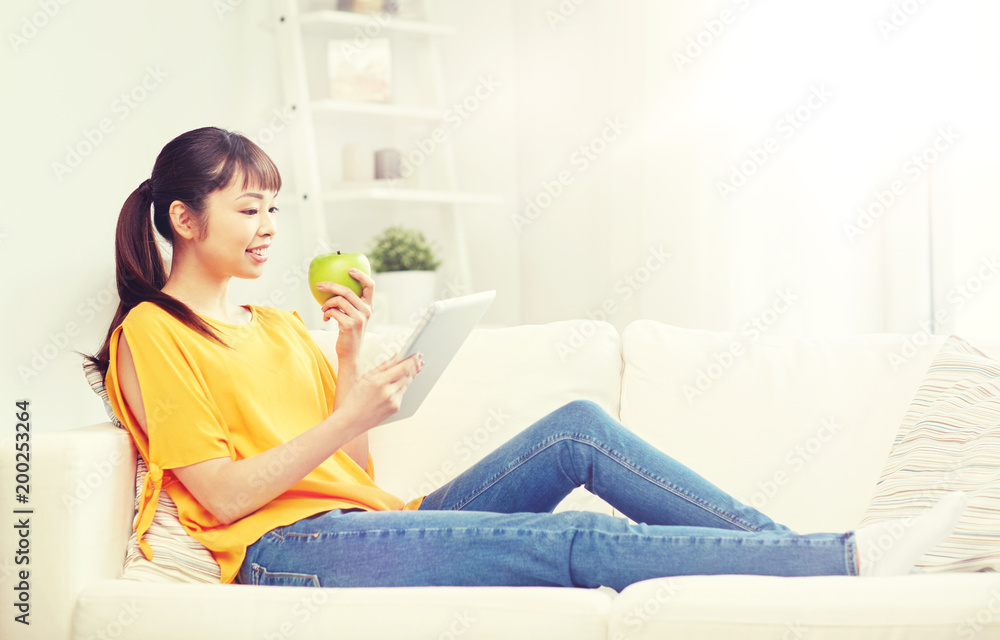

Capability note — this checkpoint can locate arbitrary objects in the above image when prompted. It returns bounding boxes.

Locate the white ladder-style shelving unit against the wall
[273,0,502,300]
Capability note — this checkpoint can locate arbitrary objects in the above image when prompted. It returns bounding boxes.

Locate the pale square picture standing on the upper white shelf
[327,38,392,102]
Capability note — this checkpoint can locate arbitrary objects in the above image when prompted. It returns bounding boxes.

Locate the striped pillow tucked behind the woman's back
[83,360,222,584]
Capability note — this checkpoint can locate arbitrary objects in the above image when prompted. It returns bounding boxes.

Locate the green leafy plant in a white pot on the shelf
[367,225,442,325]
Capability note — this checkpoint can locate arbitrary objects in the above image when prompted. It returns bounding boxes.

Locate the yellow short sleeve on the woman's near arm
[115,311,236,469]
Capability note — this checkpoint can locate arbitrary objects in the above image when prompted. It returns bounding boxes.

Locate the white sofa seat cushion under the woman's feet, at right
[608,573,1000,640]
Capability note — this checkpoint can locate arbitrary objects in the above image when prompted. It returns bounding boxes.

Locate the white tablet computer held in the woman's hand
[380,289,497,424]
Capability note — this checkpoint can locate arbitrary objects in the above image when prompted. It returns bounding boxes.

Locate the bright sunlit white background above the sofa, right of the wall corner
[504,0,1000,336]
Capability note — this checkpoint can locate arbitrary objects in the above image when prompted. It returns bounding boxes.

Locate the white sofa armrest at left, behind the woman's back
[0,422,136,640]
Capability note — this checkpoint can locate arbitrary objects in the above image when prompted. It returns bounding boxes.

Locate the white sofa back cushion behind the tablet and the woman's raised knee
[314,320,621,514]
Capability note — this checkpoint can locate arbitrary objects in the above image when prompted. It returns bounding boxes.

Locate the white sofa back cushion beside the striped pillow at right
[621,320,944,533]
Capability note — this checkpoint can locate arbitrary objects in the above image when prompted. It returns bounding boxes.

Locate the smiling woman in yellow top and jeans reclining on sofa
[91,127,965,590]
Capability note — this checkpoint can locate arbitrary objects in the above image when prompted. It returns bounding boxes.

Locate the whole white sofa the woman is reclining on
[0,320,1000,640]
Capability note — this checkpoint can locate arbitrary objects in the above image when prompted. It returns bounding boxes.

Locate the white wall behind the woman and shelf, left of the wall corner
[0,0,519,431]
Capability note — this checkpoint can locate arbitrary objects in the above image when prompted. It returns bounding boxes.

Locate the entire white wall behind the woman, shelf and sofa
[7,0,1000,430]
